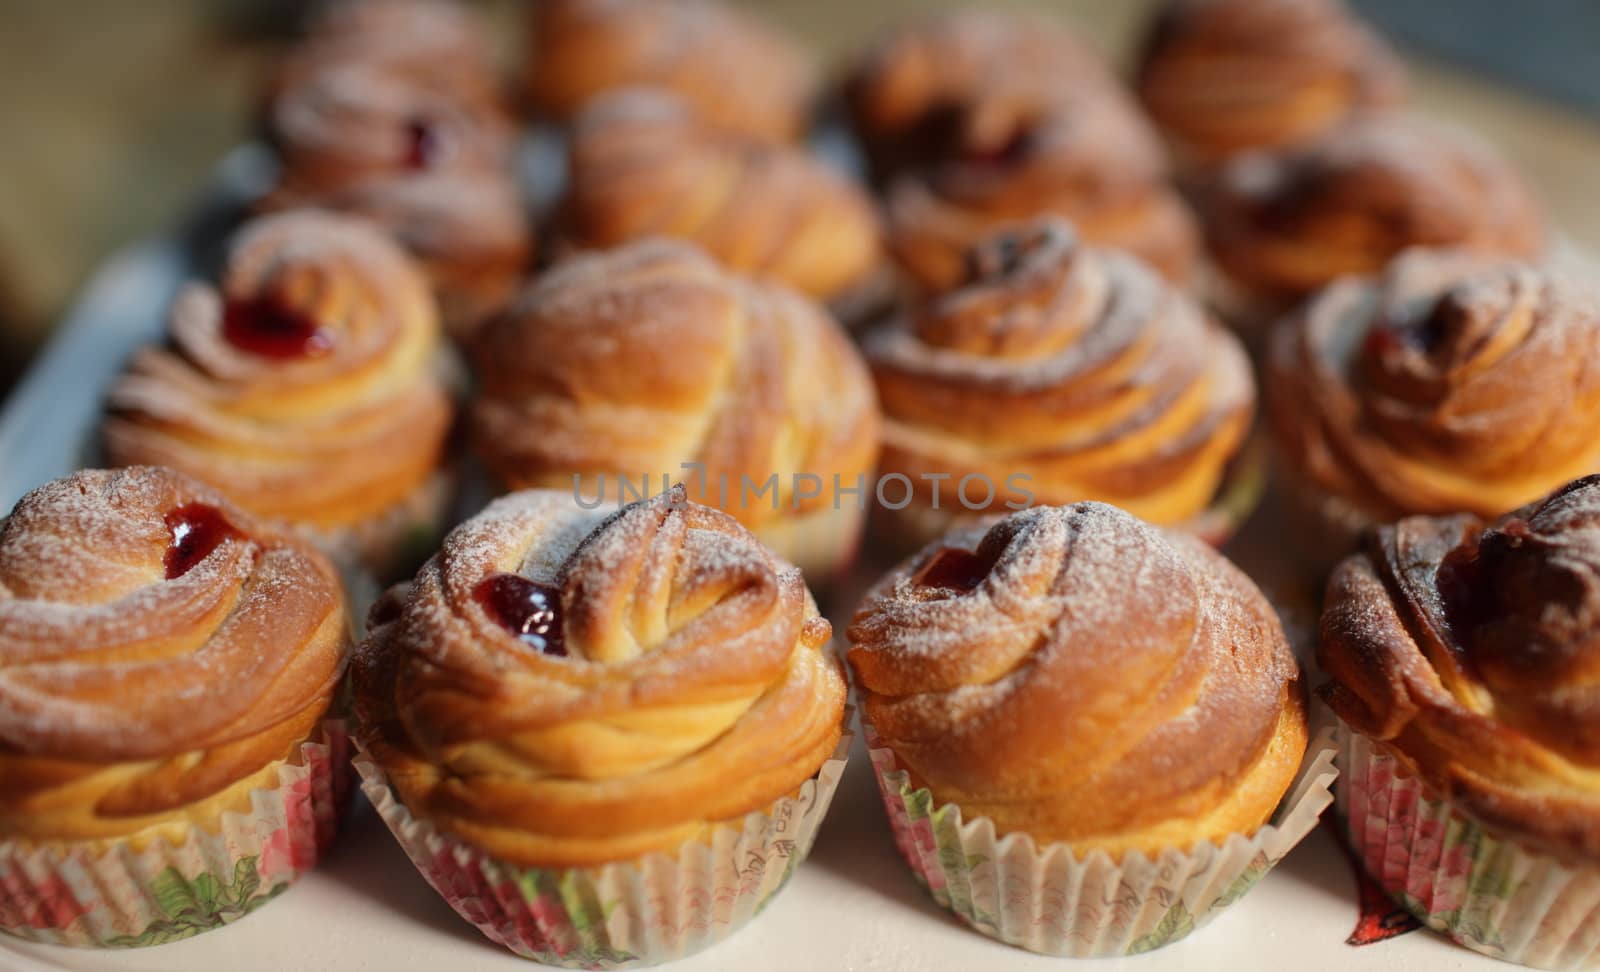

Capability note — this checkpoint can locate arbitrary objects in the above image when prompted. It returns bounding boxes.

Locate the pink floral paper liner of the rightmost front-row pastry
[1336,726,1600,969]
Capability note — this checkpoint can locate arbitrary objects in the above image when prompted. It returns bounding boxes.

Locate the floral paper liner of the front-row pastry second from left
[355,716,851,969]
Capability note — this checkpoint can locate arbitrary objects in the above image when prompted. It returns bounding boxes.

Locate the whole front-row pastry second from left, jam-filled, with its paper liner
[354,486,845,967]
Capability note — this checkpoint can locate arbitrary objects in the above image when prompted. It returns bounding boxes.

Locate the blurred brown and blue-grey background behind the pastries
[0,0,1600,396]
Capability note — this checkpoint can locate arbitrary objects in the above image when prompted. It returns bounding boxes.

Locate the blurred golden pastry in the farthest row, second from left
[526,0,816,142]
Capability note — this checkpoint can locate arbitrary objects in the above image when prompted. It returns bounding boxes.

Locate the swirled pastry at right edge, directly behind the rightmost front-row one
[1266,251,1600,521]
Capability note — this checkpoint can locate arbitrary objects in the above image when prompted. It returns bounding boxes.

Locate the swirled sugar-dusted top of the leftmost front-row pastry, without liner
[0,467,347,839]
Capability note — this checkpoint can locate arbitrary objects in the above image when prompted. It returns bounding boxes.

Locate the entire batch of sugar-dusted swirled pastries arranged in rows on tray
[0,0,1600,967]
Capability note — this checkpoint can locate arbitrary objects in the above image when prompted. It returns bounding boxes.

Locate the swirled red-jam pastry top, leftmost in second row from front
[104,211,451,528]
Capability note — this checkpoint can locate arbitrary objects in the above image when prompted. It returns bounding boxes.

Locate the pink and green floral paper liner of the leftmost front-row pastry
[0,721,350,948]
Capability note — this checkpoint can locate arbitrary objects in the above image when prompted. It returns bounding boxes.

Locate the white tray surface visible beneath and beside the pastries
[0,150,1506,972]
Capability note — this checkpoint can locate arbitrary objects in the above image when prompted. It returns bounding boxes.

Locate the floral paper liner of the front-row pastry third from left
[867,727,1336,958]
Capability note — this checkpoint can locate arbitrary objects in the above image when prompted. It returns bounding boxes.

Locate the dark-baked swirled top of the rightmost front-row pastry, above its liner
[1317,476,1600,862]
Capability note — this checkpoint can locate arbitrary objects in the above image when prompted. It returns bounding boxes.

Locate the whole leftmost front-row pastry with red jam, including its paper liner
[0,467,349,946]
